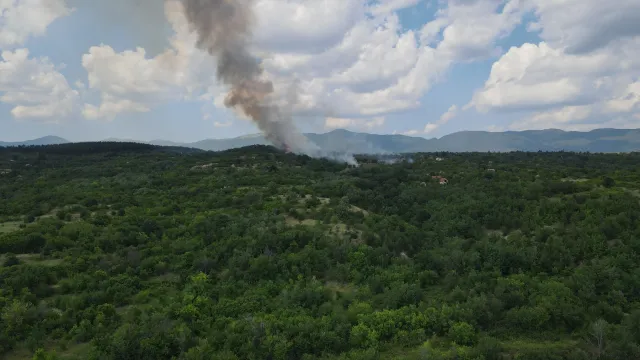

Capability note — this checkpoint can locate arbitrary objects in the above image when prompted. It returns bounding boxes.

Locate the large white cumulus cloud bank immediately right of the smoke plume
[251,0,521,117]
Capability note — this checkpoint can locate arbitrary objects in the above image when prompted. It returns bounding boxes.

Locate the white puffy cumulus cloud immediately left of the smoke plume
[82,1,216,119]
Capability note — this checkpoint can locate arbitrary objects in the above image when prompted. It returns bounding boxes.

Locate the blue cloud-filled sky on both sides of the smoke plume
[0,0,640,142]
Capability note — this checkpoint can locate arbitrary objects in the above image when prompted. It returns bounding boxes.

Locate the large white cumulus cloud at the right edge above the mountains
[468,0,640,130]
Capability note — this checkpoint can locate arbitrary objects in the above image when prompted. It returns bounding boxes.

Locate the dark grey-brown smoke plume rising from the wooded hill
[182,0,355,163]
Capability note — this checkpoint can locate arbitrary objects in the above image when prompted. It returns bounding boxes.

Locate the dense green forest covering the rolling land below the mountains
[0,143,640,360]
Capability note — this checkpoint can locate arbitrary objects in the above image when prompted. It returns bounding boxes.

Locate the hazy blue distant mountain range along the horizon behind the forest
[0,129,640,154]
